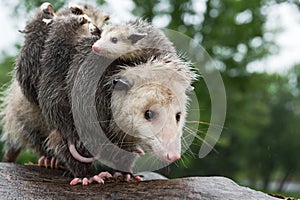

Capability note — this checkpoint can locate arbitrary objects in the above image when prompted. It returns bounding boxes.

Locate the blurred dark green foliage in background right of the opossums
[0,0,300,197]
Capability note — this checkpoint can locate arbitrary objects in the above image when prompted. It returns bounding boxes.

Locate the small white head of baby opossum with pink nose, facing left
[92,25,147,59]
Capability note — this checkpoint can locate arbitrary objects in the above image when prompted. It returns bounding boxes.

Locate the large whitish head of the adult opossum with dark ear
[111,57,192,162]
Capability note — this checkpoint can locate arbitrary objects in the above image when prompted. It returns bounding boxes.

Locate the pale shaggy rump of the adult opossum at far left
[1,80,53,162]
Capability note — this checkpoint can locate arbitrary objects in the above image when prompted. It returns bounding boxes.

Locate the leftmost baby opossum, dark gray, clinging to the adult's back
[15,3,54,104]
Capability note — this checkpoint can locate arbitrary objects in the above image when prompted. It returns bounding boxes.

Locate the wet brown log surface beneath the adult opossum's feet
[0,163,278,200]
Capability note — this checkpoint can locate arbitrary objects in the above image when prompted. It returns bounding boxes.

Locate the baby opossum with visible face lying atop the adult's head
[92,19,177,61]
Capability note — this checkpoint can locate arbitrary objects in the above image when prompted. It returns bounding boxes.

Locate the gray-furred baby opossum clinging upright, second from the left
[38,7,107,134]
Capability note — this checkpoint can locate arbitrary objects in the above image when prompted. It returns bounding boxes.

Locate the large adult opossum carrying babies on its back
[4,54,193,185]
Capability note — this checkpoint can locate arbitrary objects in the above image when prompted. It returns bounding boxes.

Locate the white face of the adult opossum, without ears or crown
[112,83,185,162]
